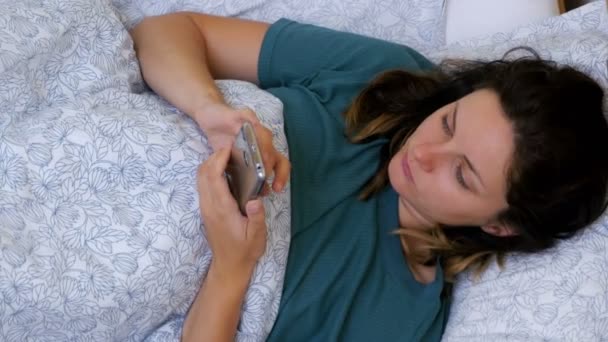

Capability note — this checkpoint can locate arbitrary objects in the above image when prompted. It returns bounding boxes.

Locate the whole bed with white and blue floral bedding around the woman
[0,0,608,341]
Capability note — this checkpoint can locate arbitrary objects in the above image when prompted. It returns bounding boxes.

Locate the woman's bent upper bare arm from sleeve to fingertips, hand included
[130,12,290,191]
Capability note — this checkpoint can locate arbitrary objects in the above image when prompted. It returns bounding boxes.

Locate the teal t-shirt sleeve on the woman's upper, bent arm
[258,19,434,88]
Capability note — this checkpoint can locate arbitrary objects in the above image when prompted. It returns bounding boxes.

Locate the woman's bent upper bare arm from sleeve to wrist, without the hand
[131,12,269,122]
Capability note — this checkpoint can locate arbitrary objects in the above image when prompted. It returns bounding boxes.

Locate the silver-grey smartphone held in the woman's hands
[226,122,266,215]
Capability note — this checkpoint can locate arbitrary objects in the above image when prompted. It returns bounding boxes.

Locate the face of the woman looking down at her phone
[388,89,514,228]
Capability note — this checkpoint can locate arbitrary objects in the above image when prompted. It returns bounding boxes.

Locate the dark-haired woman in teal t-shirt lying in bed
[132,13,608,341]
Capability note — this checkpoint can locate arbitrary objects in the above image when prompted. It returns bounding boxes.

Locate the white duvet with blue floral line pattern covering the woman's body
[0,0,290,342]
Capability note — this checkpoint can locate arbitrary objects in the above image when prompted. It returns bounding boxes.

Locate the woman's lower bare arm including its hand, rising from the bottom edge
[182,149,266,342]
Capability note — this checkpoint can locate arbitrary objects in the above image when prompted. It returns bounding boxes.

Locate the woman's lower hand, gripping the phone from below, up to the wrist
[197,149,267,277]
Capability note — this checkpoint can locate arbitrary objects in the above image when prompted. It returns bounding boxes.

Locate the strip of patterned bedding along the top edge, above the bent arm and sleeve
[112,0,445,52]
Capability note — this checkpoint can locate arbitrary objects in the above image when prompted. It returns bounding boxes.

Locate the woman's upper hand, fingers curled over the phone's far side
[195,102,291,192]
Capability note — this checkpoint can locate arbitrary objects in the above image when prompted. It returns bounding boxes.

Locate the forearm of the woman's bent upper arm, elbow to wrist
[131,13,223,119]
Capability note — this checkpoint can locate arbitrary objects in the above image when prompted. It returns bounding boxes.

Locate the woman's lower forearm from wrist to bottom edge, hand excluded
[182,265,253,342]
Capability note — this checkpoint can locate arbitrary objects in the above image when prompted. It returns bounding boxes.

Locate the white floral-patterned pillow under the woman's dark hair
[431,1,608,342]
